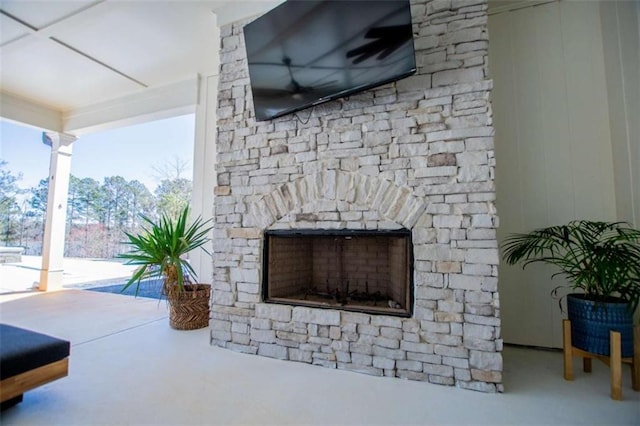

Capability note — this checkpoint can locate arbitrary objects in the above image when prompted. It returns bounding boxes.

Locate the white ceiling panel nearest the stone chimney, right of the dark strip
[48,2,218,85]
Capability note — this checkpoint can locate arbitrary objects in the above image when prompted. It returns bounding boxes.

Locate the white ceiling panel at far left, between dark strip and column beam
[0,38,140,110]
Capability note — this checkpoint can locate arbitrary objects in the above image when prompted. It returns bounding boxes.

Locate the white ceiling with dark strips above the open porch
[0,0,282,133]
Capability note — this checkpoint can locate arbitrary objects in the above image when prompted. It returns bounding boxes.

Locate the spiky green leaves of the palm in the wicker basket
[118,206,213,295]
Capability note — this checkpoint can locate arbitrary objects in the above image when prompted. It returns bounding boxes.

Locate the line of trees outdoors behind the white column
[0,160,192,258]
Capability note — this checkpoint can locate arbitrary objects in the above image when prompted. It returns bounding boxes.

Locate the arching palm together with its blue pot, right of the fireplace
[502,220,640,357]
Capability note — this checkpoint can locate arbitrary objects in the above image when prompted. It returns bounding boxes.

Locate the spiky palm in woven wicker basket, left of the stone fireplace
[119,206,212,330]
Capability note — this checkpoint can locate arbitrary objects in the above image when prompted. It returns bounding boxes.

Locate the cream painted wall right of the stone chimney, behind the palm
[489,1,628,347]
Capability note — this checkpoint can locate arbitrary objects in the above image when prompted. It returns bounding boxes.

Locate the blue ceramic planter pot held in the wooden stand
[567,294,633,358]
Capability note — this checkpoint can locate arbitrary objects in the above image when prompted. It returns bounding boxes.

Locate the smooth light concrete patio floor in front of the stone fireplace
[0,290,640,425]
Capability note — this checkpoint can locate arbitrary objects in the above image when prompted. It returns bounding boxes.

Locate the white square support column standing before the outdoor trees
[39,133,76,291]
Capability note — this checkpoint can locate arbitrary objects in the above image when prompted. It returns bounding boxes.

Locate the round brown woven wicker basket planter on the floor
[167,284,211,330]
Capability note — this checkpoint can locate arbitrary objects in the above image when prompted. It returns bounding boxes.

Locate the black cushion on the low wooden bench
[0,324,71,380]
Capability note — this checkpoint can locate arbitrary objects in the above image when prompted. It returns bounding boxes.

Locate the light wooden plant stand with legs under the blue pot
[562,320,640,401]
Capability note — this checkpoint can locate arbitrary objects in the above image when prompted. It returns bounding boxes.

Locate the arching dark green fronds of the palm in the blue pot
[502,220,640,312]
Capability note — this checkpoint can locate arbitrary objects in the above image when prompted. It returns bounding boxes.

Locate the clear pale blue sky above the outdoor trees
[0,114,195,192]
